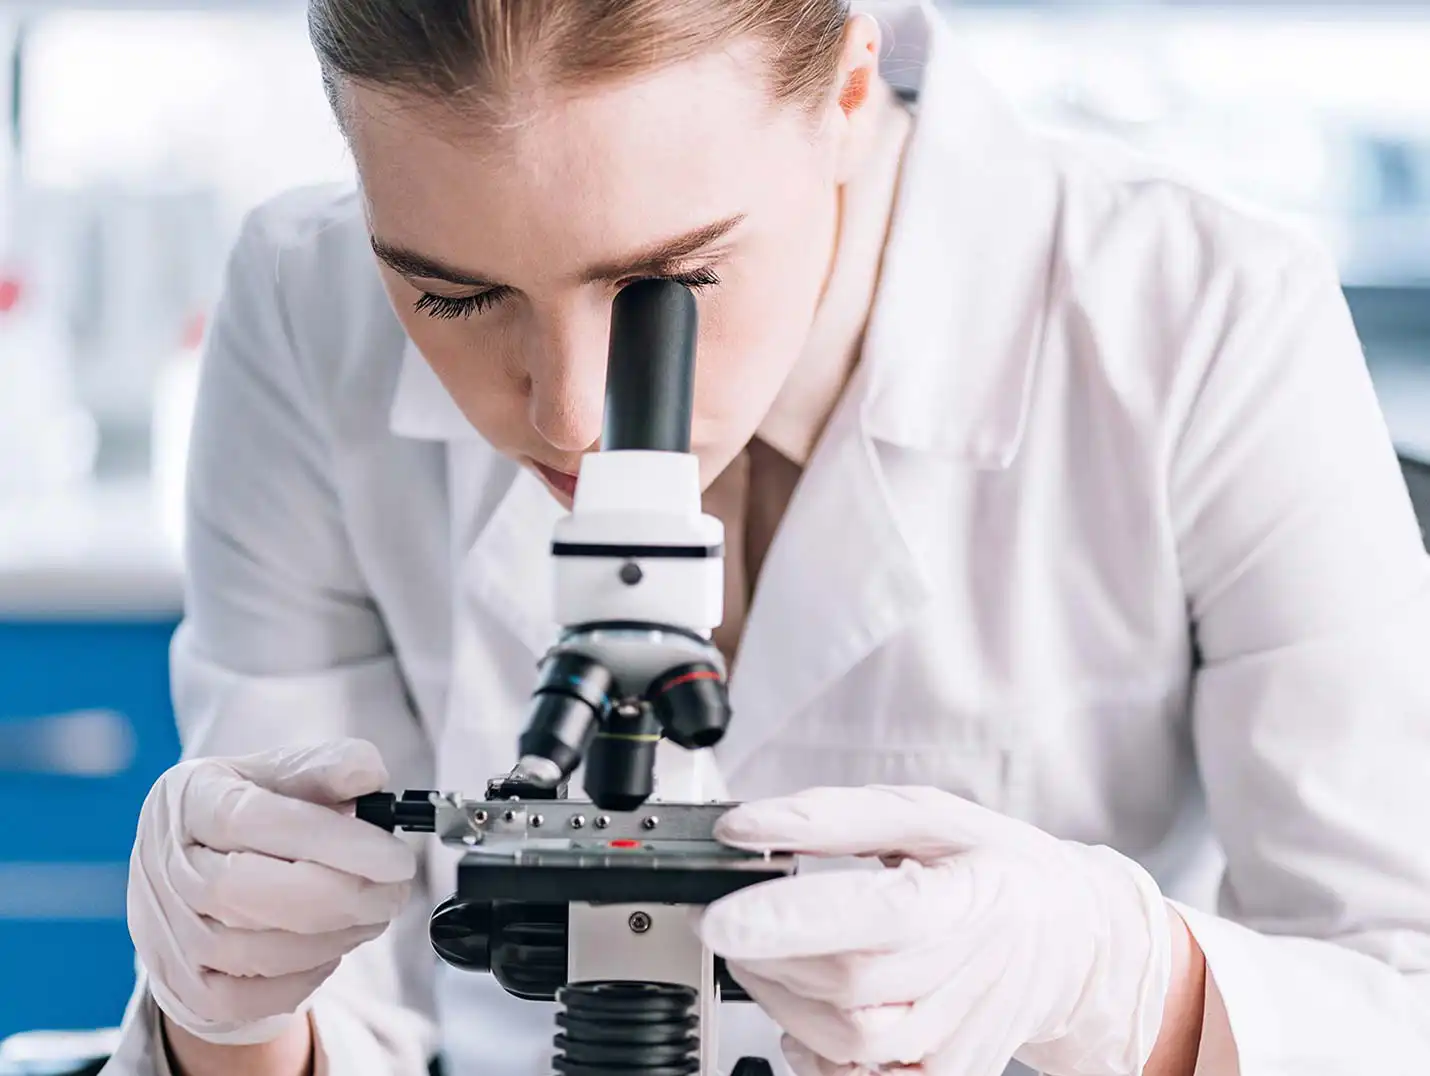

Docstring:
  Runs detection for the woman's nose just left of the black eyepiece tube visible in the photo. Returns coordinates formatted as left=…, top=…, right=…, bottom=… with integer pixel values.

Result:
left=528, top=309, right=609, bottom=452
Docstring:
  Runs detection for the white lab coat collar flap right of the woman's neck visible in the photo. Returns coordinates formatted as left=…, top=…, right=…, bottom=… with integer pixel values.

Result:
left=862, top=4, right=1060, bottom=469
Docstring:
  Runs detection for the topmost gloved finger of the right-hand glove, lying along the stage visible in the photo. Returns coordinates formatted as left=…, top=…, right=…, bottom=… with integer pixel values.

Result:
left=715, top=786, right=1050, bottom=861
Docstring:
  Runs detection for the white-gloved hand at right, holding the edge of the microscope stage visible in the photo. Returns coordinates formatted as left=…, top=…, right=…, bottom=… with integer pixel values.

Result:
left=699, top=787, right=1171, bottom=1076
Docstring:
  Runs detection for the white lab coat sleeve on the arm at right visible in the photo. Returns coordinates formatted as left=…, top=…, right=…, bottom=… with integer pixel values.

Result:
left=1167, top=253, right=1430, bottom=1076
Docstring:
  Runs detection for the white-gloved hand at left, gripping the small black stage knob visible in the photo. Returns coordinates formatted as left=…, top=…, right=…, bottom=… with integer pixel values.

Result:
left=129, top=740, right=416, bottom=1043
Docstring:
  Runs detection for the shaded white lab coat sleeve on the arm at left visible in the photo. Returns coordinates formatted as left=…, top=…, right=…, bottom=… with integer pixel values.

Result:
left=103, top=201, right=435, bottom=1076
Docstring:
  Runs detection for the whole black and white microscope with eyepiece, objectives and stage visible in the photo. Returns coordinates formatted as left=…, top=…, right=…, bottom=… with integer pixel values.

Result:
left=358, top=279, right=795, bottom=1076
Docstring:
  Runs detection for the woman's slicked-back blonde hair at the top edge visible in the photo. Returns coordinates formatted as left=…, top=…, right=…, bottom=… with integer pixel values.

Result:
left=307, top=0, right=849, bottom=121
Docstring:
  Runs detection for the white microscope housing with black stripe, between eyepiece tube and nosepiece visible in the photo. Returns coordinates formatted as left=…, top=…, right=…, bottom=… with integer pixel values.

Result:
left=555, top=452, right=725, bottom=635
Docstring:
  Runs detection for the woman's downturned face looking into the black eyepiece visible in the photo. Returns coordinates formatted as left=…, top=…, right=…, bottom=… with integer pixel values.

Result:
left=343, top=32, right=877, bottom=505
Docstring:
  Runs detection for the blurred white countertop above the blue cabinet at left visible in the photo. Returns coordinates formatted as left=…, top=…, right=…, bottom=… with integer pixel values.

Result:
left=0, top=479, right=183, bottom=620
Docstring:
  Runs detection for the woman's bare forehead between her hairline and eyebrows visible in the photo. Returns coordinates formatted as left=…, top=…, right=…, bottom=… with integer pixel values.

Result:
left=346, top=53, right=811, bottom=280
